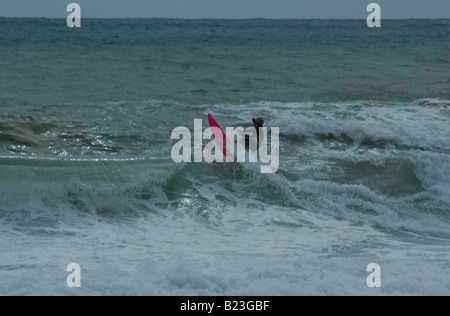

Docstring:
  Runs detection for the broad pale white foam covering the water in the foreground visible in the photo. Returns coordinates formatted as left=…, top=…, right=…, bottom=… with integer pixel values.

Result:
left=0, top=206, right=450, bottom=296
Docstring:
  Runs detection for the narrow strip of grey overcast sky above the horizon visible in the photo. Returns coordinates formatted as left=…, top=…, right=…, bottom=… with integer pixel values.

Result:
left=0, top=0, right=450, bottom=19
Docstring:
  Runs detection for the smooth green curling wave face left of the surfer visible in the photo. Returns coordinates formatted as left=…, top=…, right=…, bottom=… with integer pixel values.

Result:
left=0, top=157, right=180, bottom=226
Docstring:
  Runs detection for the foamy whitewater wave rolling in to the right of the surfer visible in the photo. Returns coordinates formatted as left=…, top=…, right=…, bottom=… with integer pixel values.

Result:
left=283, top=101, right=450, bottom=152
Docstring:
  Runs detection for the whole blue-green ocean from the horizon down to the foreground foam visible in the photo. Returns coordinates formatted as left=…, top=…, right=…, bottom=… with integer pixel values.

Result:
left=0, top=18, right=450, bottom=296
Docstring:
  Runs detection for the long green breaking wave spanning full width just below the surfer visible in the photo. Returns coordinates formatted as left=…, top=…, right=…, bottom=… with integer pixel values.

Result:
left=0, top=148, right=450, bottom=234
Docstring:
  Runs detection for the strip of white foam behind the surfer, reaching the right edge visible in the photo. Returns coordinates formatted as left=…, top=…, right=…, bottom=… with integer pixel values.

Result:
left=224, top=99, right=450, bottom=151
